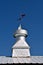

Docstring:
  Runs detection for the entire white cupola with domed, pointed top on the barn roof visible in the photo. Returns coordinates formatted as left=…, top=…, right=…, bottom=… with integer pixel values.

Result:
left=12, top=25, right=30, bottom=57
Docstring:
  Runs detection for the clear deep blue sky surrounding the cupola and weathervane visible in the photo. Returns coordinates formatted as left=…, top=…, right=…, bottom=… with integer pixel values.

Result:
left=0, top=0, right=43, bottom=56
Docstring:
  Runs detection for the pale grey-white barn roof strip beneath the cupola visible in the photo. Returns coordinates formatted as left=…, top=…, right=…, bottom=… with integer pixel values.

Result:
left=0, top=56, right=43, bottom=64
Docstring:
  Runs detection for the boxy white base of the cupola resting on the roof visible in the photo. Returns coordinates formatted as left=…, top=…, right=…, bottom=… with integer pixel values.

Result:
left=12, top=49, right=30, bottom=57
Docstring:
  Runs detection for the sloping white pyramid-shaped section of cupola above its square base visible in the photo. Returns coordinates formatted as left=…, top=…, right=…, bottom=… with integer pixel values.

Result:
left=12, top=40, right=30, bottom=49
